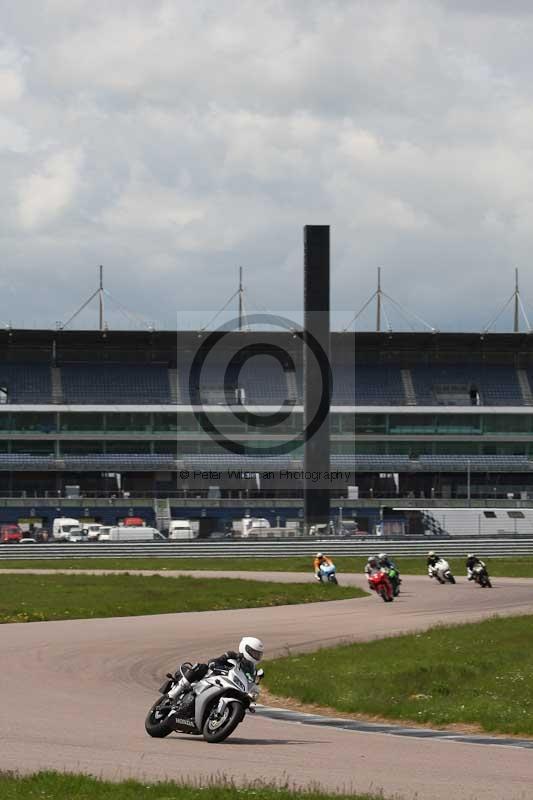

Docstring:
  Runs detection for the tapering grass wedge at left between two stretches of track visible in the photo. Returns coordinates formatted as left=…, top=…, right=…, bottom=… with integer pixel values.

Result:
left=0, top=574, right=365, bottom=623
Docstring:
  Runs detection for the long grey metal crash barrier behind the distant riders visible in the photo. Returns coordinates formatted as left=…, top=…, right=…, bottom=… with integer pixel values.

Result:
left=0, top=536, right=533, bottom=563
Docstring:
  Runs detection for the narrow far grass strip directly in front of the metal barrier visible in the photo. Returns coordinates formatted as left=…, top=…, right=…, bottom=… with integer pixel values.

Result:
left=0, top=544, right=533, bottom=578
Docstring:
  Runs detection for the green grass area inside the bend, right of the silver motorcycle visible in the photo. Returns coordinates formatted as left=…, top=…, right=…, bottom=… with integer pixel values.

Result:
left=264, top=616, right=533, bottom=735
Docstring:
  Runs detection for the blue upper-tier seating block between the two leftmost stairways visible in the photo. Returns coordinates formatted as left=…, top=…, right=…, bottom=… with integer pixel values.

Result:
left=61, top=364, right=171, bottom=405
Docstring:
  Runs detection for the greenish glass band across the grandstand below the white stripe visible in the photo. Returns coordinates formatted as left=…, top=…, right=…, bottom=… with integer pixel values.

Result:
left=0, top=409, right=533, bottom=458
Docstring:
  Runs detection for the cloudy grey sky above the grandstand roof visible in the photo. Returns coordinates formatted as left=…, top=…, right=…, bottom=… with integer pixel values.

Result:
left=0, top=0, right=533, bottom=331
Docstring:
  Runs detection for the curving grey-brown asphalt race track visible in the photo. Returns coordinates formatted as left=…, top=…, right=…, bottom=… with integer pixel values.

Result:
left=0, top=570, right=533, bottom=800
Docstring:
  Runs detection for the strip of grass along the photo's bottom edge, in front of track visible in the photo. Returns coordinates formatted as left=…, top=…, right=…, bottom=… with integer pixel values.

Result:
left=0, top=772, right=382, bottom=800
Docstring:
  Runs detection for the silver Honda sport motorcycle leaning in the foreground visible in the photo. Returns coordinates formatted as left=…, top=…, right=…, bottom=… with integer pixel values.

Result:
left=144, top=659, right=264, bottom=743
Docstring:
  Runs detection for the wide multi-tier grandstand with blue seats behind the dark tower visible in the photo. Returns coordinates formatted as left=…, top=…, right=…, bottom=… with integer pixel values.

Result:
left=0, top=329, right=533, bottom=527
